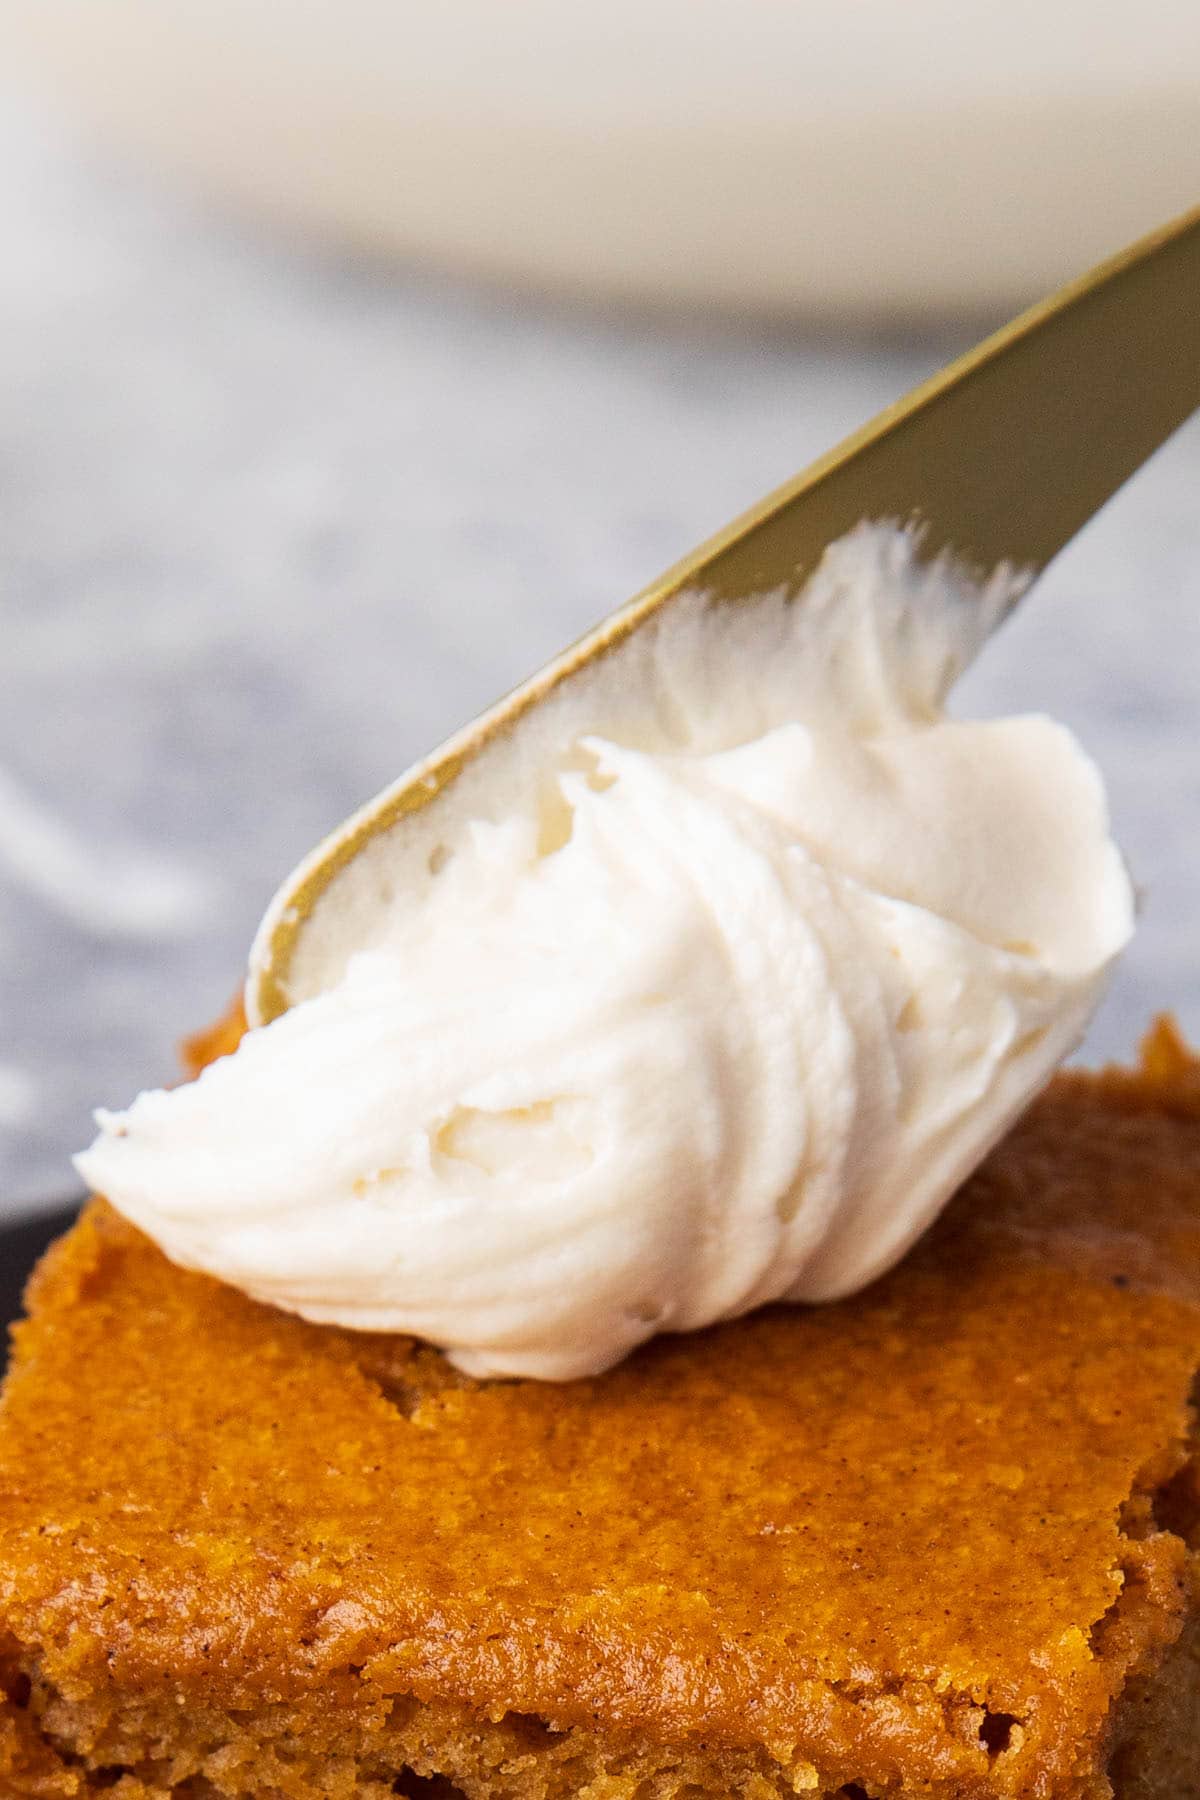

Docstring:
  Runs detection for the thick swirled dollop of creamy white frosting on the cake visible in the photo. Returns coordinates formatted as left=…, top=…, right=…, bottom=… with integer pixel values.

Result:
left=77, top=527, right=1133, bottom=1379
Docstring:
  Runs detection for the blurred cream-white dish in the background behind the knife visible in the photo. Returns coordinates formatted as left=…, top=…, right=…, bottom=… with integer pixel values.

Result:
left=0, top=0, right=1200, bottom=319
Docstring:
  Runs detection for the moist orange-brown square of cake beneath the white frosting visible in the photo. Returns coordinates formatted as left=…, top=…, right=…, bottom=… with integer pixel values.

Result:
left=0, top=1026, right=1200, bottom=1800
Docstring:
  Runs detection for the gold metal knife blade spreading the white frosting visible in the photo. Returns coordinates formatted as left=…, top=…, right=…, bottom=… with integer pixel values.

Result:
left=246, top=207, right=1200, bottom=1024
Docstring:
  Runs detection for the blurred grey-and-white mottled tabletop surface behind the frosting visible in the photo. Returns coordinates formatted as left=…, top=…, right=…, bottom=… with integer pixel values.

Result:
left=0, top=97, right=1200, bottom=1213
